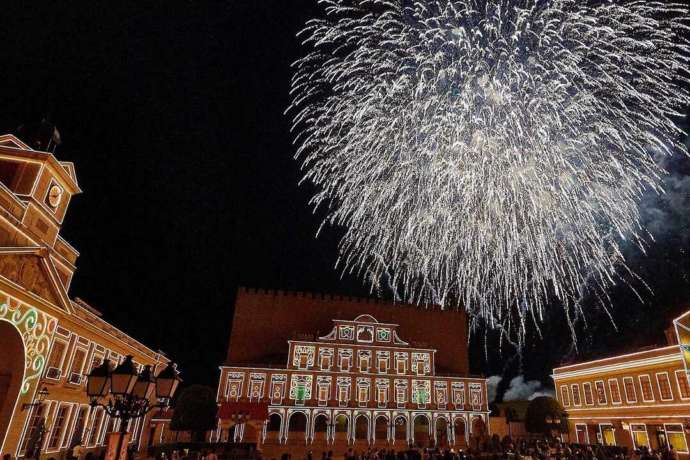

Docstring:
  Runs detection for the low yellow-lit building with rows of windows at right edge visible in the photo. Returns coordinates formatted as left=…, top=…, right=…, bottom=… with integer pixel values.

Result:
left=553, top=312, right=690, bottom=457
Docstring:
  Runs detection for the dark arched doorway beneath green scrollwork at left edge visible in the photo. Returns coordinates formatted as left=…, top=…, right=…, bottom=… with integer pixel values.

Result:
left=0, top=320, right=25, bottom=452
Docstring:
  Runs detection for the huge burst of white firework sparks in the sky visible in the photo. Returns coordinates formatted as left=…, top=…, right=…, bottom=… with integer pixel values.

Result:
left=290, top=0, right=690, bottom=342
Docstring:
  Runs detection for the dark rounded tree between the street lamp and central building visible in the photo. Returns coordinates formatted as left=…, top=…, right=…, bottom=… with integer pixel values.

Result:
left=170, top=385, right=218, bottom=441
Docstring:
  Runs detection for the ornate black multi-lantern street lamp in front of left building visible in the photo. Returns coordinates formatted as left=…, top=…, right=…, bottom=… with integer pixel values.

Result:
left=86, top=355, right=182, bottom=460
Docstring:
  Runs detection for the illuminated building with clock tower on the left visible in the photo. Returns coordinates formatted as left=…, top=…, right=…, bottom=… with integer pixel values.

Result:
left=0, top=135, right=169, bottom=458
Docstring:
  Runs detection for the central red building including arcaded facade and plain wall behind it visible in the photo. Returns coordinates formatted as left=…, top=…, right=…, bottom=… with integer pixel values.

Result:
left=214, top=289, right=488, bottom=450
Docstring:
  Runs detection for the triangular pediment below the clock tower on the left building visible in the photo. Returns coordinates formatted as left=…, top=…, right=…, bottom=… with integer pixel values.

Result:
left=0, top=248, right=70, bottom=311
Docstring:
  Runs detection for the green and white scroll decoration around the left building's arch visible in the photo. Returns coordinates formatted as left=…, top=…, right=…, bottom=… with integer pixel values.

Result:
left=0, top=297, right=57, bottom=395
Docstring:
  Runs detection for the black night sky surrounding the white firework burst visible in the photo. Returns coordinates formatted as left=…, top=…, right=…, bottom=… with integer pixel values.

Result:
left=0, top=0, right=690, bottom=398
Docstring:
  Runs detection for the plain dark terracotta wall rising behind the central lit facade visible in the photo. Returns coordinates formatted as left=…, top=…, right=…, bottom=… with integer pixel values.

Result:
left=226, top=288, right=469, bottom=374
